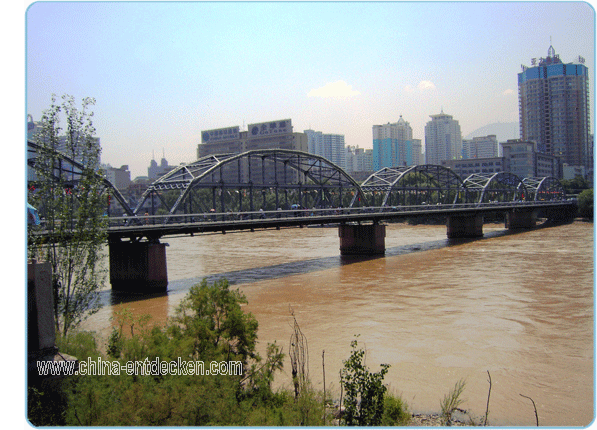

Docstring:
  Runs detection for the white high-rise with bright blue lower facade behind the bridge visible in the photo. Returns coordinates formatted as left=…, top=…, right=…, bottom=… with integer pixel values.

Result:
left=373, top=115, right=421, bottom=170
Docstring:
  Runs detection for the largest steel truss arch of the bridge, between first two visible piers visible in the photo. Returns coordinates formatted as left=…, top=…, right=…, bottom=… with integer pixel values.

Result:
left=133, top=149, right=366, bottom=220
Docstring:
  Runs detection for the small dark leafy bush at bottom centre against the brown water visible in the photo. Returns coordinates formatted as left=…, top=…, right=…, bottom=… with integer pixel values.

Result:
left=340, top=339, right=390, bottom=426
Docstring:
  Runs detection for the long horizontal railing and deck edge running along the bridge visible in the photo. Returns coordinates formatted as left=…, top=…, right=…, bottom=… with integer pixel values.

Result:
left=103, top=199, right=574, bottom=228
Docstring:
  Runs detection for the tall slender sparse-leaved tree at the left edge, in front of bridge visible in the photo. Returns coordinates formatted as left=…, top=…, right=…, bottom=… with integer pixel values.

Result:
left=28, top=95, right=107, bottom=335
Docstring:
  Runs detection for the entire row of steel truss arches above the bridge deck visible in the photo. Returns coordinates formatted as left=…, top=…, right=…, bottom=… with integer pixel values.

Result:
left=27, top=141, right=565, bottom=222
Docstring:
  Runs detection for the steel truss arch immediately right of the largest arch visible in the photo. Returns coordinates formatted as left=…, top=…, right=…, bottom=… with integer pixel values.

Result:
left=354, top=164, right=465, bottom=210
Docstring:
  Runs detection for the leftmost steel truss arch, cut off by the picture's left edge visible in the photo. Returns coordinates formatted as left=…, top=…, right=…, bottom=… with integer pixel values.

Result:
left=27, top=140, right=133, bottom=215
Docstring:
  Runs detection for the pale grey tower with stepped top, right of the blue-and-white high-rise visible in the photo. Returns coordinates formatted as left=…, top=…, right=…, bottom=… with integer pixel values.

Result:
left=425, top=110, right=462, bottom=165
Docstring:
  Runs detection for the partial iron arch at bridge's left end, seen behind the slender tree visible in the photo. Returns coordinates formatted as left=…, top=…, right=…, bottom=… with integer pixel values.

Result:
left=27, top=140, right=133, bottom=215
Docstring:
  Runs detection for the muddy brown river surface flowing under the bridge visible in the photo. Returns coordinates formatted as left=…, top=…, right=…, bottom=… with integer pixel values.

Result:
left=83, top=222, right=595, bottom=426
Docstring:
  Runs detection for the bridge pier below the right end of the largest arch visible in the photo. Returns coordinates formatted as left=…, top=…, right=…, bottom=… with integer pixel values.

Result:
left=338, top=224, right=386, bottom=255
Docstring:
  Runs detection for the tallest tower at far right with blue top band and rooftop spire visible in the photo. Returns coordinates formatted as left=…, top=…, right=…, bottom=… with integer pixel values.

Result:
left=518, top=46, right=592, bottom=175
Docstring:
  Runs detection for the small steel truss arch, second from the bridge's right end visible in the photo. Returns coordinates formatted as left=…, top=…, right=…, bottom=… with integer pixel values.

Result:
left=464, top=172, right=528, bottom=203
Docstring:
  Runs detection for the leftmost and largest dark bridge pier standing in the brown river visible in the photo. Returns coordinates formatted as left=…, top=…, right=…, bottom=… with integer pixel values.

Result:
left=109, top=241, right=168, bottom=293
